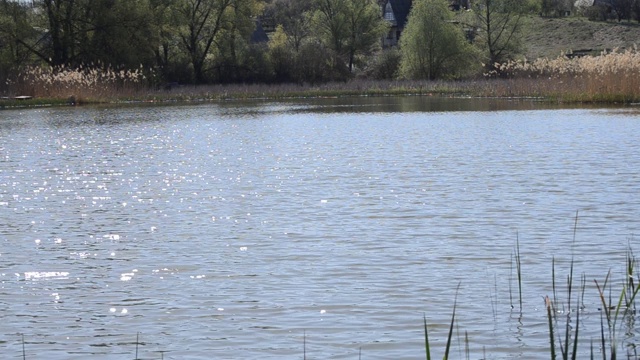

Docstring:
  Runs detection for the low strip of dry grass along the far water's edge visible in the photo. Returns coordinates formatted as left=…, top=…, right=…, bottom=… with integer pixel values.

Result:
left=0, top=78, right=640, bottom=109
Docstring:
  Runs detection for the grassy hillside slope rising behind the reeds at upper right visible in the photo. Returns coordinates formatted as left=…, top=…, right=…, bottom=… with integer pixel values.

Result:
left=524, top=16, right=640, bottom=60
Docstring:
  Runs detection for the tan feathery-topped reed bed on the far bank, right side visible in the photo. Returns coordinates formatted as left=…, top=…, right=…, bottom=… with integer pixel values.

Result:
left=478, top=49, right=640, bottom=103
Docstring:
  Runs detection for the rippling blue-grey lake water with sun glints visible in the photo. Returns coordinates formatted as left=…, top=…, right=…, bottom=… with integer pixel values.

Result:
left=0, top=97, right=640, bottom=360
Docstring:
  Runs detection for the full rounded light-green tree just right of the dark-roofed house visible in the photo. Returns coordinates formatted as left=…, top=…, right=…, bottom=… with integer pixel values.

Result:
left=400, top=0, right=475, bottom=80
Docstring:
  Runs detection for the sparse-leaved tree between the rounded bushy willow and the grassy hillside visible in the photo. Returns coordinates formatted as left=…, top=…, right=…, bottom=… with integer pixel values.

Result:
left=474, top=0, right=528, bottom=70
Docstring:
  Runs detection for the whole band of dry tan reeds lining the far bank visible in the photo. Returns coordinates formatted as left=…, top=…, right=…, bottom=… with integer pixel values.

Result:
left=0, top=48, right=640, bottom=108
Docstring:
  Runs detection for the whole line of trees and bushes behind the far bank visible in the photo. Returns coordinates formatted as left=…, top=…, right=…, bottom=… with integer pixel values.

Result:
left=0, top=0, right=640, bottom=88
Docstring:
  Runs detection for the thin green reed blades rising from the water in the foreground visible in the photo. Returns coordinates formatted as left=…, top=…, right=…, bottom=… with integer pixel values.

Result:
left=424, top=212, right=640, bottom=360
